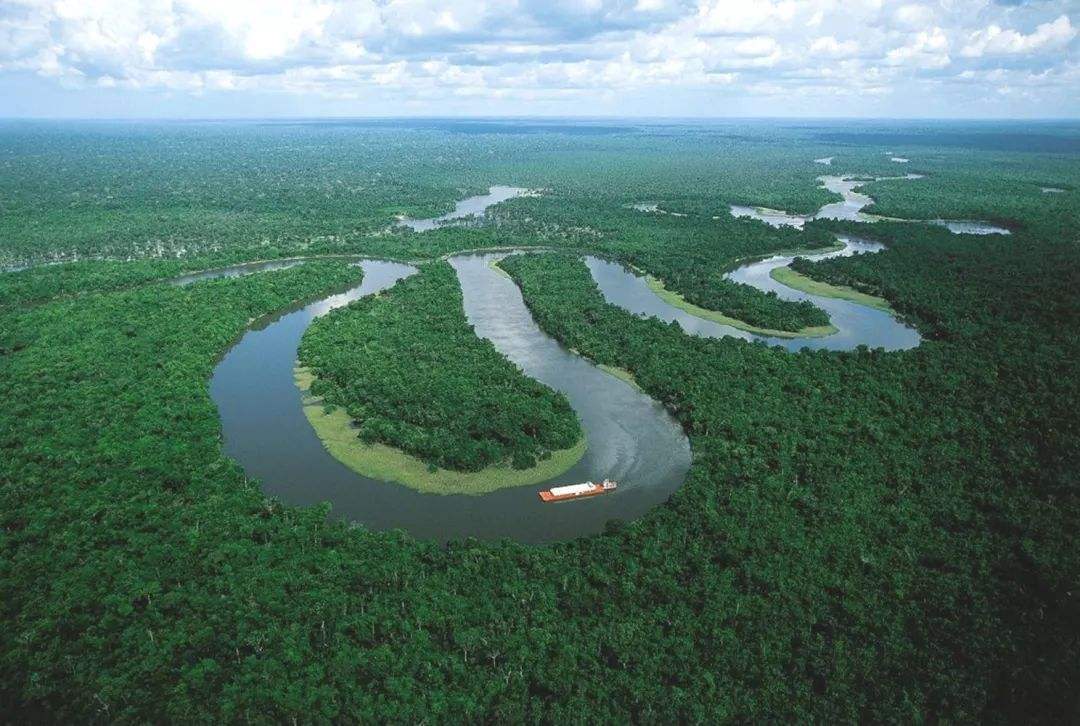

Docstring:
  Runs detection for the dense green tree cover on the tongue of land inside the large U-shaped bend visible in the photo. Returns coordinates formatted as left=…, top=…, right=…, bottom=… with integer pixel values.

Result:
left=299, top=261, right=582, bottom=471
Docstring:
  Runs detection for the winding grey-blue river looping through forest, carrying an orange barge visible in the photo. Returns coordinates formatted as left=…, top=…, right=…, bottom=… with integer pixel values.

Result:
left=206, top=187, right=919, bottom=543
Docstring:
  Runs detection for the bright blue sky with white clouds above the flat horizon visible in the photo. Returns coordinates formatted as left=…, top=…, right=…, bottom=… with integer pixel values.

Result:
left=0, top=0, right=1080, bottom=118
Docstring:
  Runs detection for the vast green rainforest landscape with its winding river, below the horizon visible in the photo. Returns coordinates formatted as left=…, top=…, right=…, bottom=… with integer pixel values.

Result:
left=0, top=119, right=1080, bottom=723
